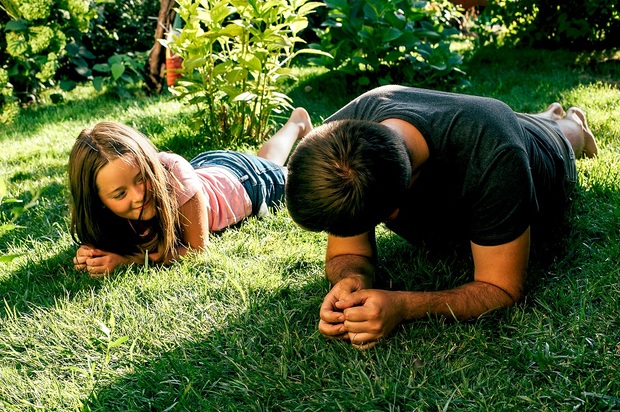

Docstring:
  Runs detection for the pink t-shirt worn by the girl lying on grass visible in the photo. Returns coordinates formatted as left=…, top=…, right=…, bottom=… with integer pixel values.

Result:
left=159, top=152, right=252, bottom=232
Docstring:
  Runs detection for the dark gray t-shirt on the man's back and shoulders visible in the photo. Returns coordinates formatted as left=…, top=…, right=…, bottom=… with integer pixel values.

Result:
left=326, top=86, right=564, bottom=246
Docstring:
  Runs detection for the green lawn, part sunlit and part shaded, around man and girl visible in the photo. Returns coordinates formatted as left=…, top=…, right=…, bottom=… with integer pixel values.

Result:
left=0, top=46, right=620, bottom=411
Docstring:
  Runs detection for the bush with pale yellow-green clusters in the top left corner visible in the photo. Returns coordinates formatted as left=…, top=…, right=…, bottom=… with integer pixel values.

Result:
left=0, top=0, right=159, bottom=123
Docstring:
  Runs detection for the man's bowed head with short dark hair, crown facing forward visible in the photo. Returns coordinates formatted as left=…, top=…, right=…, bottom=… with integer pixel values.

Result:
left=286, top=120, right=411, bottom=236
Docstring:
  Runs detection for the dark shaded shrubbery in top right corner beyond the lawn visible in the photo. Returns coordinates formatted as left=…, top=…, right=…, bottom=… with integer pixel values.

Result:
left=475, top=0, right=620, bottom=51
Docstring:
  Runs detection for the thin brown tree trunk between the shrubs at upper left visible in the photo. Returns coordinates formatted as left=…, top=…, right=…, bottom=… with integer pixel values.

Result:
left=145, top=0, right=176, bottom=94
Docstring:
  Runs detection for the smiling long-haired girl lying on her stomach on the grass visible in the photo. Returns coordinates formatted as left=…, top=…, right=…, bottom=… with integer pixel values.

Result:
left=68, top=108, right=312, bottom=277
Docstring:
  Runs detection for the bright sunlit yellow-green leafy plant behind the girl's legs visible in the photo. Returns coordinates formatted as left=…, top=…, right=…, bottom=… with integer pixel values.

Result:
left=163, top=0, right=330, bottom=145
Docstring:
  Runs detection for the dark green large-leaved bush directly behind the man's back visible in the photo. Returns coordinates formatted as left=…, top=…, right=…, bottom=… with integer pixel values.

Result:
left=311, top=0, right=465, bottom=88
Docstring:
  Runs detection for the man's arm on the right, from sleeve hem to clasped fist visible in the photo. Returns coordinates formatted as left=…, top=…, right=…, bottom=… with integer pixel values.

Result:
left=334, top=228, right=530, bottom=349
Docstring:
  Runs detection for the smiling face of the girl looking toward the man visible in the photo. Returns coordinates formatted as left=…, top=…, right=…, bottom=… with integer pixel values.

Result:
left=95, top=158, right=155, bottom=220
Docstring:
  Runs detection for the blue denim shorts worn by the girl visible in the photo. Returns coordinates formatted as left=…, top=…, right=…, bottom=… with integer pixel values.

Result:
left=189, top=150, right=286, bottom=216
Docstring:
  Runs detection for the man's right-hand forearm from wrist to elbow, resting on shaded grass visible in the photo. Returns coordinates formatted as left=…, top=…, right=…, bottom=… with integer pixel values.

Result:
left=397, top=282, right=516, bottom=320
